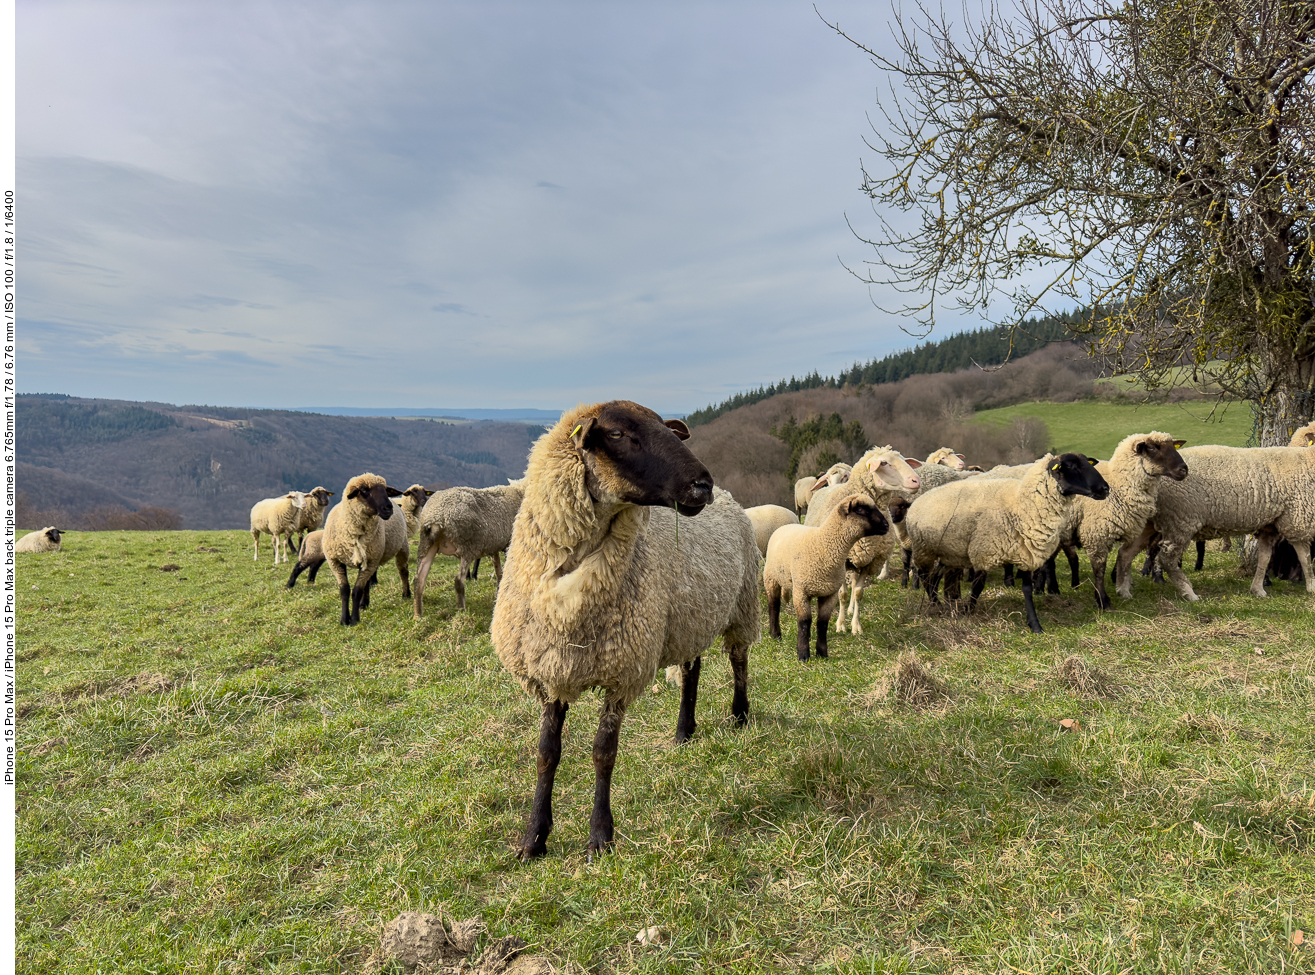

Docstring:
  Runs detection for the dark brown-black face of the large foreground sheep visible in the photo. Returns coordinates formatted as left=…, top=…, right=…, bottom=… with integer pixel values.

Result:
left=571, top=400, right=713, bottom=514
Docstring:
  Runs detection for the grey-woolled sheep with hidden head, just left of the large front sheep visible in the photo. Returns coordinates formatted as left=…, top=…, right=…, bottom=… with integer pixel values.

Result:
left=414, top=478, right=525, bottom=620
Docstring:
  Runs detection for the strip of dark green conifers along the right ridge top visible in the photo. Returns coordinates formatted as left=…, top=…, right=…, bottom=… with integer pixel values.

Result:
left=685, top=313, right=1078, bottom=426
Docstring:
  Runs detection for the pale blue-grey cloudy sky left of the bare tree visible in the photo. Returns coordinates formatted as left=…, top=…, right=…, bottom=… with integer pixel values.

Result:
left=16, top=0, right=982, bottom=414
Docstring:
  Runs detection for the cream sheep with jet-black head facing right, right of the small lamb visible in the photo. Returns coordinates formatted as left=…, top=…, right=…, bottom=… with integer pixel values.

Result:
left=903, top=454, right=1110, bottom=633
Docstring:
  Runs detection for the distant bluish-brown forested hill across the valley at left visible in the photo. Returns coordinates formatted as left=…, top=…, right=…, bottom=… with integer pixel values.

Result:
left=17, top=395, right=543, bottom=529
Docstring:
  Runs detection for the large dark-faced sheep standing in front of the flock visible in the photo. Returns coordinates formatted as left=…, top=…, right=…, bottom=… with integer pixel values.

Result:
left=492, top=400, right=760, bottom=859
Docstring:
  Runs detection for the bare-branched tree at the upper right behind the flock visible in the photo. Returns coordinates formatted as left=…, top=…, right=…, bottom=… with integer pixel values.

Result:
left=831, top=0, right=1315, bottom=445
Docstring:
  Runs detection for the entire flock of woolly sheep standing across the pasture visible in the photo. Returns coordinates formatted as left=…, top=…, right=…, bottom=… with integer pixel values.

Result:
left=20, top=400, right=1315, bottom=858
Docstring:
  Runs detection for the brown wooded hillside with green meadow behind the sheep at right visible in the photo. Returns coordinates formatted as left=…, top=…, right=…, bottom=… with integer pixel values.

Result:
left=689, top=342, right=1230, bottom=507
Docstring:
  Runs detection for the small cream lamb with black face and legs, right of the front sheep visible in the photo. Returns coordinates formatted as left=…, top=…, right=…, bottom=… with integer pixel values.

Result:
left=763, top=493, right=890, bottom=661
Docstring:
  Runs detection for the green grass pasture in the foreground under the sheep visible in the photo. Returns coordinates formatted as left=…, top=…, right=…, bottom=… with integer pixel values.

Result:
left=16, top=528, right=1315, bottom=975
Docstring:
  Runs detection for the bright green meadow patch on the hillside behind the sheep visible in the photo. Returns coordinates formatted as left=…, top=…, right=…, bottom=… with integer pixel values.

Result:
left=973, top=400, right=1253, bottom=461
